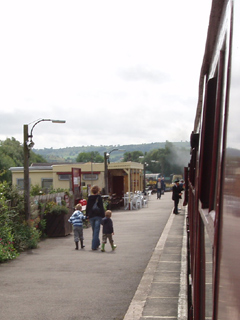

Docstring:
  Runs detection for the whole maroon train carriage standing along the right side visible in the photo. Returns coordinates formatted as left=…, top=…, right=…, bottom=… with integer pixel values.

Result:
left=185, top=0, right=240, bottom=320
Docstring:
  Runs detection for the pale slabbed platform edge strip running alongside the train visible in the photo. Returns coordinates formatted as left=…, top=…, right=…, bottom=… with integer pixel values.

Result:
left=124, top=199, right=187, bottom=320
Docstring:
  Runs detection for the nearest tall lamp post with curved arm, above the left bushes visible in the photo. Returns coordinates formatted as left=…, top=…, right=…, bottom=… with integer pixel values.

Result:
left=23, top=119, right=66, bottom=221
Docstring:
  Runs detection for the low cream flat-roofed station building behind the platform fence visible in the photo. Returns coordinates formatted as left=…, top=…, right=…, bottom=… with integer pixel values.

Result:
left=10, top=161, right=144, bottom=197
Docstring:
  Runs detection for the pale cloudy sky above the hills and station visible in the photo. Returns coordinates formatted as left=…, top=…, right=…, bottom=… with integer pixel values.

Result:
left=0, top=0, right=211, bottom=149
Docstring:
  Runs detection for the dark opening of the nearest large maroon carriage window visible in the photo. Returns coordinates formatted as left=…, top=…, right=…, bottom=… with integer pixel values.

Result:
left=200, top=51, right=225, bottom=211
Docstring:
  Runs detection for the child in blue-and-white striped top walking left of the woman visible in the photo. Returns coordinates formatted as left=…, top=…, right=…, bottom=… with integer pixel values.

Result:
left=68, top=203, right=86, bottom=250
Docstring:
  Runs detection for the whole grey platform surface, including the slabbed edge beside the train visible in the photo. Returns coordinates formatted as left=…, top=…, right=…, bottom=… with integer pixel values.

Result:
left=0, top=193, right=187, bottom=320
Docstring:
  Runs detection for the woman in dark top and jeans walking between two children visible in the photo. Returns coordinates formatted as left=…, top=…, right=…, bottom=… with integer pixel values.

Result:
left=86, top=186, right=105, bottom=250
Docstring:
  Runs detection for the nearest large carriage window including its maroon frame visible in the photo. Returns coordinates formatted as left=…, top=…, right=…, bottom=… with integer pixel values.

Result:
left=199, top=35, right=228, bottom=212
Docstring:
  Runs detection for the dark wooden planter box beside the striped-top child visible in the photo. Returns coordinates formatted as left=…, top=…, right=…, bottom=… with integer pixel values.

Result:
left=46, top=213, right=72, bottom=237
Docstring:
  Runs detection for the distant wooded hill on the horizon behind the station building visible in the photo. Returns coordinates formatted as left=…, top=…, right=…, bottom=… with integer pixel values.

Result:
left=33, top=141, right=190, bottom=162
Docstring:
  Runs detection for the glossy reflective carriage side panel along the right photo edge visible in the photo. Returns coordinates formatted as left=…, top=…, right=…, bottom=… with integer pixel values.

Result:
left=217, top=1, right=240, bottom=320
